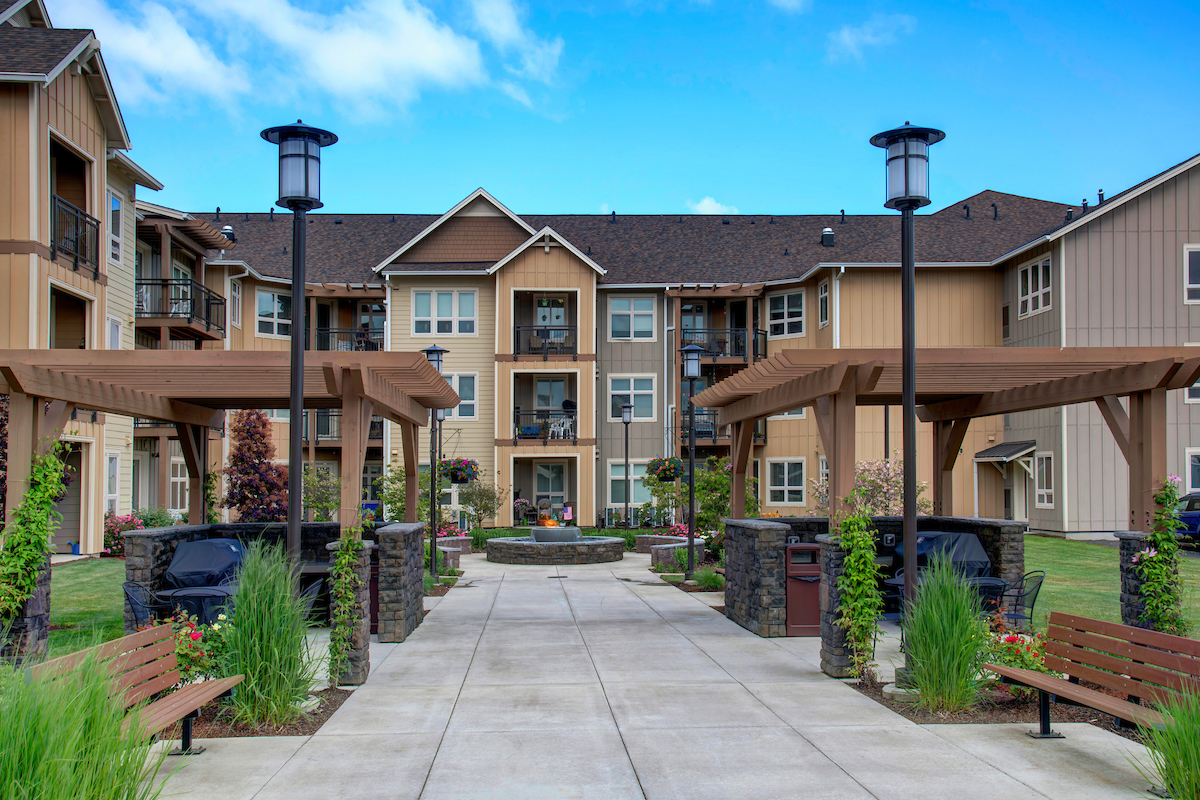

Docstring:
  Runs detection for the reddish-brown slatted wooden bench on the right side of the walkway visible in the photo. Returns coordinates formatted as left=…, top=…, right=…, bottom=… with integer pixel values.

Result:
left=984, top=612, right=1200, bottom=739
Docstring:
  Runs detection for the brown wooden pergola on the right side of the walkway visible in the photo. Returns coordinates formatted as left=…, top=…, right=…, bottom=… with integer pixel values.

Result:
left=696, top=347, right=1200, bottom=530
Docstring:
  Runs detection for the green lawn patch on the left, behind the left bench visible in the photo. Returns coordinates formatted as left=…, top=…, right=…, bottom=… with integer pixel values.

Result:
left=50, top=559, right=125, bottom=658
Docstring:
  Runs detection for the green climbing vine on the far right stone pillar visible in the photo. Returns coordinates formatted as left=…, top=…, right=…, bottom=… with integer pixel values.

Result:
left=1133, top=475, right=1188, bottom=636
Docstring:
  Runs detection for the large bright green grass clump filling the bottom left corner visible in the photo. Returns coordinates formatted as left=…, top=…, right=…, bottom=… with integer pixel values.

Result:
left=0, top=657, right=166, bottom=800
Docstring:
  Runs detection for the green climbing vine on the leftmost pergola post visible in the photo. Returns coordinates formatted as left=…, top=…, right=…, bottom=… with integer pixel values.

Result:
left=0, top=443, right=67, bottom=624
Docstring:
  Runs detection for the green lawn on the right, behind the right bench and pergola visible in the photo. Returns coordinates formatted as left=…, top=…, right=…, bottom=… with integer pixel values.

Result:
left=1025, top=536, right=1200, bottom=634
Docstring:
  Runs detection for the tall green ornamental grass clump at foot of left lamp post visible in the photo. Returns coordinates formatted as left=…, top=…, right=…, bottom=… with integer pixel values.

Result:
left=223, top=541, right=317, bottom=726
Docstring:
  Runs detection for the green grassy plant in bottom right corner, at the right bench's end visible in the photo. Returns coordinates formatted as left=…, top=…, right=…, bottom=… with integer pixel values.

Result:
left=1135, top=692, right=1200, bottom=799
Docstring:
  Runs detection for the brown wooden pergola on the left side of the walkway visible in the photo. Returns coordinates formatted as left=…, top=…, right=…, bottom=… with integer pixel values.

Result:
left=0, top=350, right=458, bottom=531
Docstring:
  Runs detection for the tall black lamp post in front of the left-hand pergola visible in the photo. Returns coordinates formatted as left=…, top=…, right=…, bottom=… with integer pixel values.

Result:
left=262, top=120, right=338, bottom=565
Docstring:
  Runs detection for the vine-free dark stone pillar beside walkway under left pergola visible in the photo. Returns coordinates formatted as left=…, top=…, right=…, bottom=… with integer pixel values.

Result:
left=376, top=522, right=425, bottom=642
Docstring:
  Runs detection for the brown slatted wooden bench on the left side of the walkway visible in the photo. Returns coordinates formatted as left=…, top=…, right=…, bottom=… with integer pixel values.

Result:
left=31, top=625, right=244, bottom=756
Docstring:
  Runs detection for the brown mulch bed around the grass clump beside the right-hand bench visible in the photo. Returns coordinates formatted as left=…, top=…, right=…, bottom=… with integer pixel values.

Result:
left=850, top=681, right=1141, bottom=741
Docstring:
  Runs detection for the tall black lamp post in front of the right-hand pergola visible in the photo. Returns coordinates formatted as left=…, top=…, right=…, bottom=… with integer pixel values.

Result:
left=871, top=122, right=946, bottom=602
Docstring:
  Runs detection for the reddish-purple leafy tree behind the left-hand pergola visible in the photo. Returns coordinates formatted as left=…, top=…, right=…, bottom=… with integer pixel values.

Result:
left=222, top=409, right=288, bottom=522
